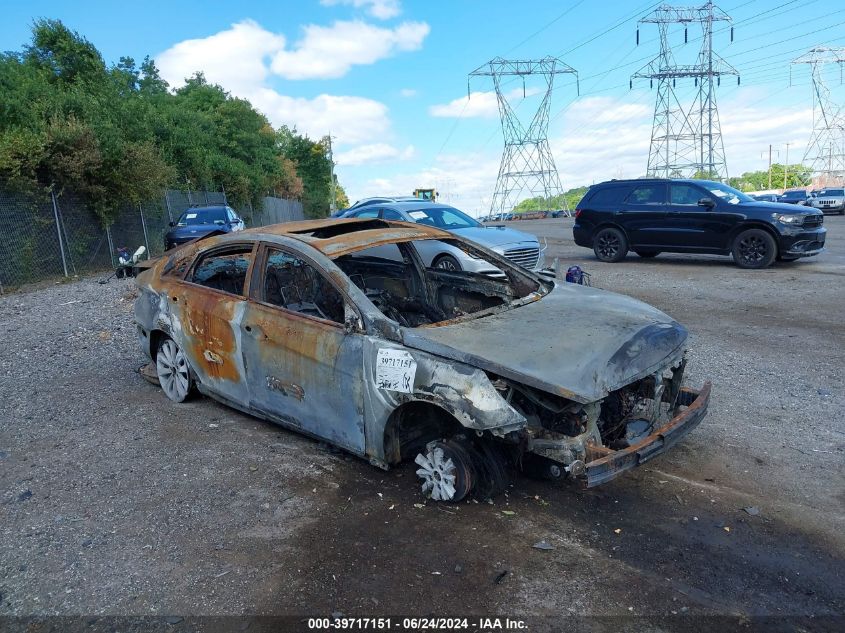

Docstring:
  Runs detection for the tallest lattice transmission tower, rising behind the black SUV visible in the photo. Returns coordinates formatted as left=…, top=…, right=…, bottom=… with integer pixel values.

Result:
left=631, top=2, right=739, bottom=180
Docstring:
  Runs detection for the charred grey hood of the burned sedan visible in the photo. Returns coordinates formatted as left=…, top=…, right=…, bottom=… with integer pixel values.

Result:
left=402, top=283, right=687, bottom=403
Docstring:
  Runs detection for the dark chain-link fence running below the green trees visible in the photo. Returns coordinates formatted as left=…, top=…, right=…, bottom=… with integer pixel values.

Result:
left=0, top=185, right=304, bottom=294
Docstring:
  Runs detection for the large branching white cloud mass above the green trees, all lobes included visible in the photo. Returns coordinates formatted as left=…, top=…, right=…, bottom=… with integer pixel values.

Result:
left=156, top=20, right=429, bottom=145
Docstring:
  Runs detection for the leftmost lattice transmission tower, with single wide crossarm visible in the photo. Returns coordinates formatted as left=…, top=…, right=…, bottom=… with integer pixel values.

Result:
left=467, top=57, right=578, bottom=214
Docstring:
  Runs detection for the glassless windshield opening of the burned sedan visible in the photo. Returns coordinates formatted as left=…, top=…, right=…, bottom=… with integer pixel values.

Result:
left=334, top=240, right=546, bottom=327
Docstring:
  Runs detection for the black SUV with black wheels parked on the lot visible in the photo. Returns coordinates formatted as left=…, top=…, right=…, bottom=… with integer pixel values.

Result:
left=572, top=179, right=827, bottom=268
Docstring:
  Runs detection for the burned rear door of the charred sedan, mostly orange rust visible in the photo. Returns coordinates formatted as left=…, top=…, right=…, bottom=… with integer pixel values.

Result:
left=176, top=243, right=255, bottom=404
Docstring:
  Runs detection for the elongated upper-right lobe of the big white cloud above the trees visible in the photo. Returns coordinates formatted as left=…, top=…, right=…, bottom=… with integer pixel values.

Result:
left=271, top=20, right=431, bottom=79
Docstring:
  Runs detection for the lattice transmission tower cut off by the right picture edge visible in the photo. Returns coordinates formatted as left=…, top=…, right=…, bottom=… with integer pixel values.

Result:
left=792, top=46, right=845, bottom=186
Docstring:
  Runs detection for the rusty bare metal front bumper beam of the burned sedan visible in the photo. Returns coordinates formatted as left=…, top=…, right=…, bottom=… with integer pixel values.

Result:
left=579, top=381, right=711, bottom=488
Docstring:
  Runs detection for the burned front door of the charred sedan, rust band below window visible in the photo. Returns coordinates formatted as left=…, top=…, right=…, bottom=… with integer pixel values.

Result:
left=240, top=245, right=364, bottom=454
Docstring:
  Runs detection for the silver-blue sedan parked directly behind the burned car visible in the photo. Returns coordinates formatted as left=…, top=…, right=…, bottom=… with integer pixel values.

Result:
left=336, top=200, right=545, bottom=275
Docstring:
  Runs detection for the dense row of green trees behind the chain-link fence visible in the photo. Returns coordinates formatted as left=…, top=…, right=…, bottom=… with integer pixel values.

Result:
left=0, top=20, right=342, bottom=222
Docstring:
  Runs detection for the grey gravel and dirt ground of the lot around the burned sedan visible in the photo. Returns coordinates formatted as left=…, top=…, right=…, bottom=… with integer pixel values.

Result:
left=0, top=217, right=845, bottom=631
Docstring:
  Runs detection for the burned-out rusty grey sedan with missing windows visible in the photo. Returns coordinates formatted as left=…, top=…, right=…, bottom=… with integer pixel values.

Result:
left=135, top=219, right=710, bottom=501
